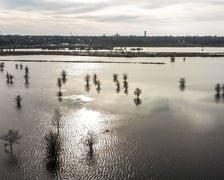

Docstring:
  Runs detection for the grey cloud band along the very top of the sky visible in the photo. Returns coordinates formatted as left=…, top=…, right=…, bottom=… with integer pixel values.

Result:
left=0, top=0, right=224, bottom=14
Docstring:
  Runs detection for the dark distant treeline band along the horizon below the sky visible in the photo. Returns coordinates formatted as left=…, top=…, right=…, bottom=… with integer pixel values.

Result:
left=0, top=35, right=224, bottom=49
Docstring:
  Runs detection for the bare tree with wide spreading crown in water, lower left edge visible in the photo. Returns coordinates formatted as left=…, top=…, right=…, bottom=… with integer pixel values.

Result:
left=0, top=129, right=22, bottom=153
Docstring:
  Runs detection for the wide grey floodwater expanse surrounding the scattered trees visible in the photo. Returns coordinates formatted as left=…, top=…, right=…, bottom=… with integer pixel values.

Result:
left=0, top=56, right=224, bottom=180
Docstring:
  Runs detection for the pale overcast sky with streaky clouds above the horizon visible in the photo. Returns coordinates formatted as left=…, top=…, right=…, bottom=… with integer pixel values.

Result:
left=0, top=0, right=224, bottom=35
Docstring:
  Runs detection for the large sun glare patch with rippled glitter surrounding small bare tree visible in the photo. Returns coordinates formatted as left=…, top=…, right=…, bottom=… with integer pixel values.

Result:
left=57, top=107, right=117, bottom=174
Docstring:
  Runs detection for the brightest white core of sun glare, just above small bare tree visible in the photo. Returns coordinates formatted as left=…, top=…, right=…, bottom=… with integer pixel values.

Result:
left=64, top=107, right=114, bottom=150
